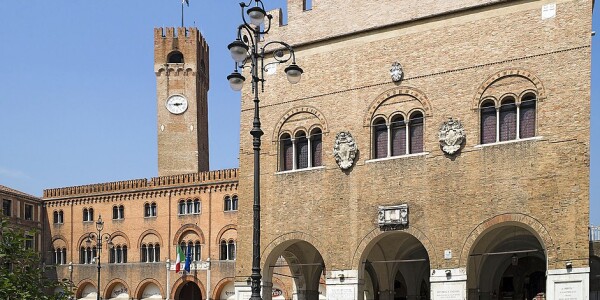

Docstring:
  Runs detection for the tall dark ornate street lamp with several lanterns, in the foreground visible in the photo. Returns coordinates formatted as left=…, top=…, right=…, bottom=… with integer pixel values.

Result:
left=227, top=0, right=303, bottom=300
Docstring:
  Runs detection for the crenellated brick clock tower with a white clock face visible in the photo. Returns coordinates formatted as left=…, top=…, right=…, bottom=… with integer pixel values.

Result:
left=154, top=27, right=209, bottom=176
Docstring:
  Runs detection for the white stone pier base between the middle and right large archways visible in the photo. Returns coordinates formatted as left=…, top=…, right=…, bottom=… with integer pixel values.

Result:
left=429, top=268, right=467, bottom=300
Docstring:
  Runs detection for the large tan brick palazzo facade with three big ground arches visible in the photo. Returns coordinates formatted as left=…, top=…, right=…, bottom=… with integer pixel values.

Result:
left=236, top=0, right=592, bottom=299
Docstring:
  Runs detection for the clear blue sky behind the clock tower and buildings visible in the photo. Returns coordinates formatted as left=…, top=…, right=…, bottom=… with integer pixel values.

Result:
left=0, top=0, right=600, bottom=225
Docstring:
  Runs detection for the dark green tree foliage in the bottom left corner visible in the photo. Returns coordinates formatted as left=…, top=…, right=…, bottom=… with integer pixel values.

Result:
left=0, top=219, right=69, bottom=300
